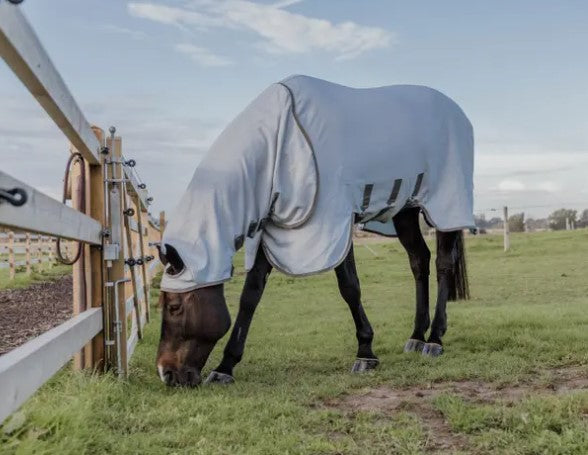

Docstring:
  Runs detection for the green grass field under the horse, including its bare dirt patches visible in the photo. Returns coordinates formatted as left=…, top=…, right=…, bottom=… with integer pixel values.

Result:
left=0, top=230, right=588, bottom=454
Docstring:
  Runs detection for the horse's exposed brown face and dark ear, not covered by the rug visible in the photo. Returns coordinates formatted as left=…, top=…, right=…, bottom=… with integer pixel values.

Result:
left=157, top=246, right=231, bottom=387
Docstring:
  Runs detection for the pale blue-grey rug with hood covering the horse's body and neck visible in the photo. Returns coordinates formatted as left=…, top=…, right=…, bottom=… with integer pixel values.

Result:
left=161, top=76, right=475, bottom=292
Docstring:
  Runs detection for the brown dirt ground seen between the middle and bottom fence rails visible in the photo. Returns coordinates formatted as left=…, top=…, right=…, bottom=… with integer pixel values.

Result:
left=0, top=276, right=72, bottom=355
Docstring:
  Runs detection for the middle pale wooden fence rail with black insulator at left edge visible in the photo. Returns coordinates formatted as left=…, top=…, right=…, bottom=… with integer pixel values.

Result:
left=0, top=171, right=102, bottom=245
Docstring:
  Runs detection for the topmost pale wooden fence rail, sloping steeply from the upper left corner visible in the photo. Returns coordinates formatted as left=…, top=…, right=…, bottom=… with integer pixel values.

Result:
left=0, top=1, right=100, bottom=164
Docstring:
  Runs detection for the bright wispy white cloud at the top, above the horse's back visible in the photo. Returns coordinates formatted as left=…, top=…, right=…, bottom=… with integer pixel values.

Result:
left=128, top=0, right=394, bottom=59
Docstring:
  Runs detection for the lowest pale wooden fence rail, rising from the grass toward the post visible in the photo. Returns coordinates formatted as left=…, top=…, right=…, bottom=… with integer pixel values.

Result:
left=0, top=308, right=102, bottom=422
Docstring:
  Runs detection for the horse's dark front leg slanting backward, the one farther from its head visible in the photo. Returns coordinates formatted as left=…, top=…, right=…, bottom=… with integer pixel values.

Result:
left=335, top=247, right=379, bottom=373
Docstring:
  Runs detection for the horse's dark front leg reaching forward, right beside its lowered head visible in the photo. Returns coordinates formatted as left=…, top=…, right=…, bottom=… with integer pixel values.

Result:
left=206, top=246, right=272, bottom=384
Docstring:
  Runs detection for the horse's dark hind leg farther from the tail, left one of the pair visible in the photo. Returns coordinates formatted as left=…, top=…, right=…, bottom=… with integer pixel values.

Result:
left=394, top=208, right=431, bottom=352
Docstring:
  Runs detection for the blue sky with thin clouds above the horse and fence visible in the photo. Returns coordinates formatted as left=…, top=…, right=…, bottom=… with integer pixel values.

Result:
left=0, top=0, right=588, bottom=217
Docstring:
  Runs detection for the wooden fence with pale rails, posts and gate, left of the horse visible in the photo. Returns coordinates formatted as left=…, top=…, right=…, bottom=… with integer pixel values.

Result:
left=0, top=1, right=164, bottom=422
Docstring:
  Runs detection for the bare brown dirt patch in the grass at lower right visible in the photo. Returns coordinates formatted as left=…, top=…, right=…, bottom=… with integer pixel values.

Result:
left=323, top=366, right=588, bottom=453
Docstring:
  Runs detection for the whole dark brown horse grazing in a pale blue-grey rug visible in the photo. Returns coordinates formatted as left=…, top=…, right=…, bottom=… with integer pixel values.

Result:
left=157, top=76, right=475, bottom=386
